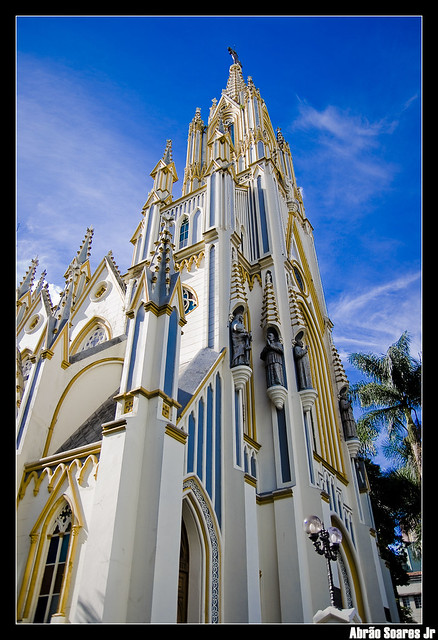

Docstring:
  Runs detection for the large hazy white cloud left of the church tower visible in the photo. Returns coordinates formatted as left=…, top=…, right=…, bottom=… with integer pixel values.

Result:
left=17, top=60, right=161, bottom=285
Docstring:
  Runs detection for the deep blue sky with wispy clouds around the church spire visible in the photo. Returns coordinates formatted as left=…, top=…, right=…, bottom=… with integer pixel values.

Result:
left=16, top=16, right=422, bottom=396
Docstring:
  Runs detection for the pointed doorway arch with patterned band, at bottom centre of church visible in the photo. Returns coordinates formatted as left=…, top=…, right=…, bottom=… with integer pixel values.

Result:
left=183, top=475, right=221, bottom=623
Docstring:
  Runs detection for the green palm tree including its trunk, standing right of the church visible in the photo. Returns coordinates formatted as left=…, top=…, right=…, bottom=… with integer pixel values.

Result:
left=349, top=331, right=422, bottom=557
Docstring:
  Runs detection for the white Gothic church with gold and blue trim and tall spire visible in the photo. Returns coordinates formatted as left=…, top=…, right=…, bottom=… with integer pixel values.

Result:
left=16, top=50, right=398, bottom=624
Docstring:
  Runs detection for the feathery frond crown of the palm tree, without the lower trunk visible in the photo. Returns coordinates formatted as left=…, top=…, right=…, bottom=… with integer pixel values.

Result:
left=349, top=331, right=422, bottom=482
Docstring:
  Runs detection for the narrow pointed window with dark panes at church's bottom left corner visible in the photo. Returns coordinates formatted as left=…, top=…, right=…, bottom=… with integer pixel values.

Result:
left=33, top=504, right=72, bottom=623
